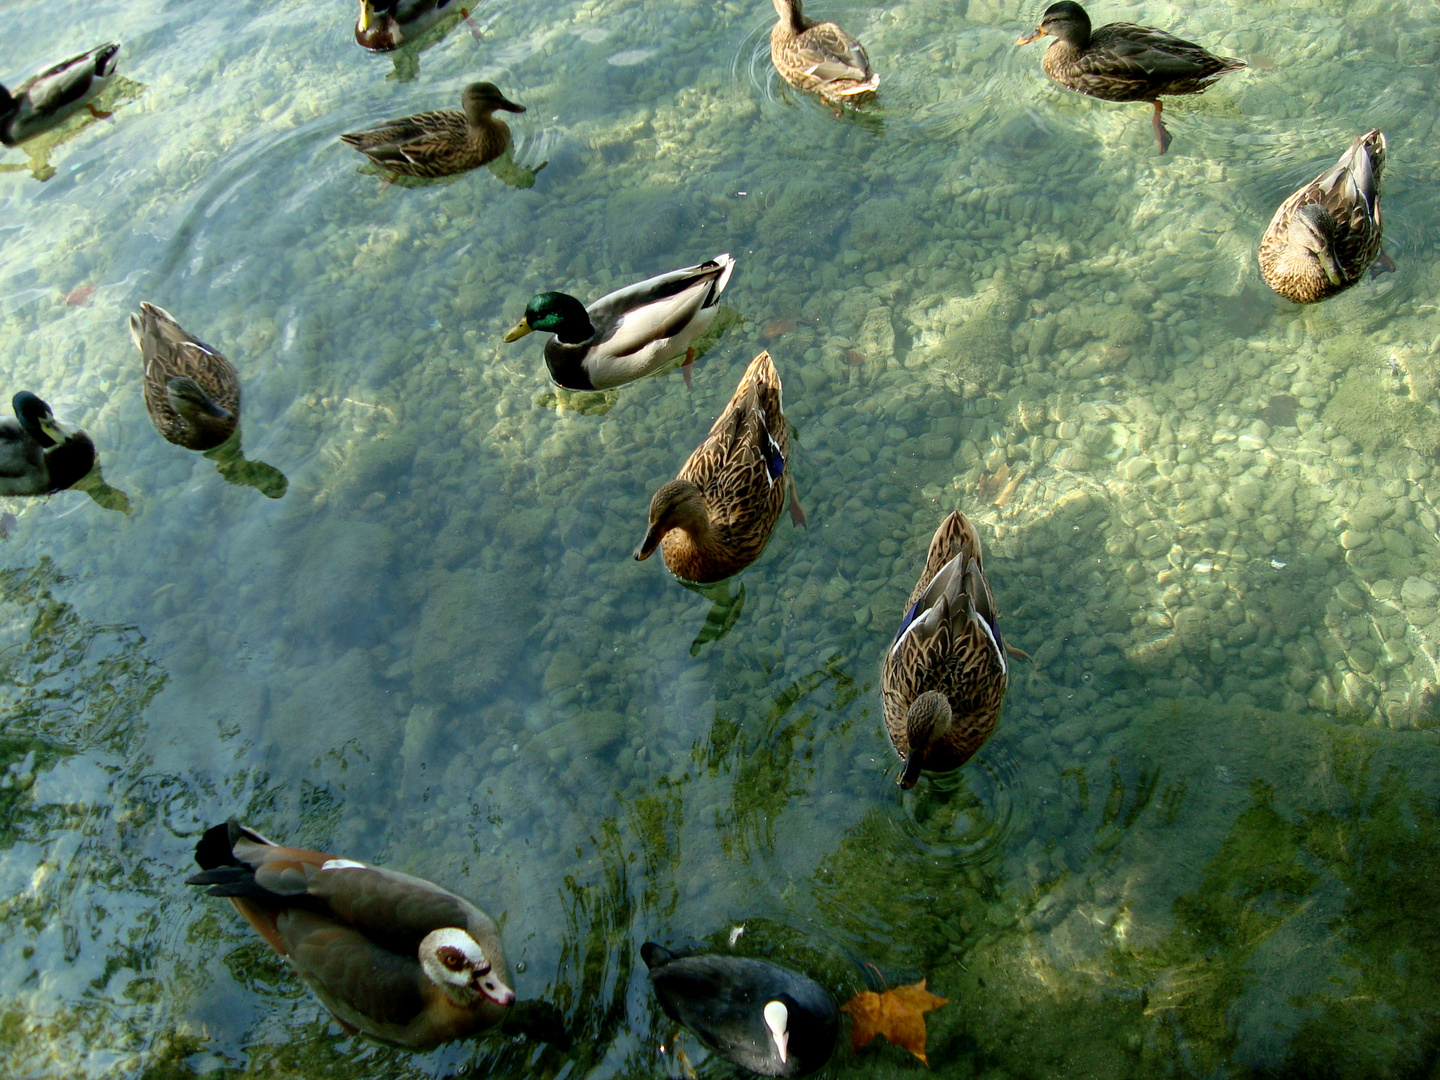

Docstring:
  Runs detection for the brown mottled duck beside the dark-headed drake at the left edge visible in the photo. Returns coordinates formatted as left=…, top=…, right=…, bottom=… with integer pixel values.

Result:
left=130, top=301, right=240, bottom=451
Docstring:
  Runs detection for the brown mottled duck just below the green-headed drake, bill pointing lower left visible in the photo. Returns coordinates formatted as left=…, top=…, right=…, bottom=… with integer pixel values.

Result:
left=635, top=353, right=805, bottom=585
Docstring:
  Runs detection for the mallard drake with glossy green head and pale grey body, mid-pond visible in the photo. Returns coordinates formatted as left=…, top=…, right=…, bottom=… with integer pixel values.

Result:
left=505, top=255, right=731, bottom=390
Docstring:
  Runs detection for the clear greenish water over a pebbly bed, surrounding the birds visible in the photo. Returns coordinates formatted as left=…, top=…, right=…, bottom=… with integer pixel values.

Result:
left=0, top=0, right=1440, bottom=1079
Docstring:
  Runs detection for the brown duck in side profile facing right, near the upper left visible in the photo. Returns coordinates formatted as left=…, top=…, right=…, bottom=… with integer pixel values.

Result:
left=340, top=82, right=526, bottom=177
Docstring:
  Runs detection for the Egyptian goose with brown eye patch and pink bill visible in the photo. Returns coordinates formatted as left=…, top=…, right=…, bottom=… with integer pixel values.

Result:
left=186, top=821, right=516, bottom=1050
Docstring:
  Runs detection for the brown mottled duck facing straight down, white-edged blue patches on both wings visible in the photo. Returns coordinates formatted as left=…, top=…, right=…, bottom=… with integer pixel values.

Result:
left=880, top=510, right=1022, bottom=788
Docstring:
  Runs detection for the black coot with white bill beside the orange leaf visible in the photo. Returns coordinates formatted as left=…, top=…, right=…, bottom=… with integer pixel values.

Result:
left=639, top=942, right=840, bottom=1076
